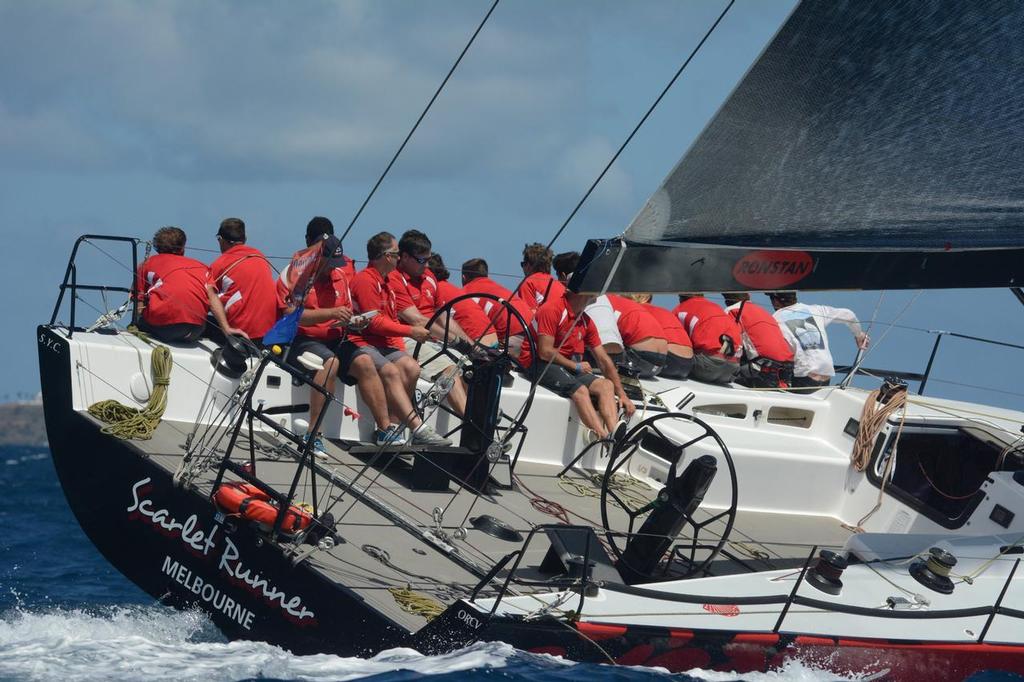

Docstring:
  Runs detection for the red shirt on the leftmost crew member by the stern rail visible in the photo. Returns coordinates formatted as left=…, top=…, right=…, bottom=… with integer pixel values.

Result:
left=135, top=253, right=209, bottom=326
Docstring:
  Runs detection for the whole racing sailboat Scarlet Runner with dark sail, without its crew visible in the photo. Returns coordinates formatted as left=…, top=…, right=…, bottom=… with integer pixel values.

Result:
left=32, top=0, right=1024, bottom=679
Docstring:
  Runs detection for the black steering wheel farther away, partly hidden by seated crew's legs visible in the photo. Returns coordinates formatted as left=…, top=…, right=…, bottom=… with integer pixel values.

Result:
left=413, top=293, right=537, bottom=452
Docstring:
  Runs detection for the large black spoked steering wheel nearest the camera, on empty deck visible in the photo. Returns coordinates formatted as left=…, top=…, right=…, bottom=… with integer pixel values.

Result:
left=601, top=412, right=738, bottom=582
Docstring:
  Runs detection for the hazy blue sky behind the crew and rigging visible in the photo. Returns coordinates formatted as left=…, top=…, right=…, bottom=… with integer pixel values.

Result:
left=0, top=0, right=1024, bottom=409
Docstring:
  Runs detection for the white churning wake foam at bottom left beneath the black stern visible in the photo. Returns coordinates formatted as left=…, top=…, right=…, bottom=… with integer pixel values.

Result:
left=0, top=606, right=515, bottom=682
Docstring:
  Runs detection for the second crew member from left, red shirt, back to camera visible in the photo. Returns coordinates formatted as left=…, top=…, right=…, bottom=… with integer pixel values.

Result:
left=206, top=218, right=278, bottom=343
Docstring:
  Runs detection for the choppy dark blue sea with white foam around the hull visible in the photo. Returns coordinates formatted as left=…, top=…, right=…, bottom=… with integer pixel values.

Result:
left=0, top=447, right=1022, bottom=682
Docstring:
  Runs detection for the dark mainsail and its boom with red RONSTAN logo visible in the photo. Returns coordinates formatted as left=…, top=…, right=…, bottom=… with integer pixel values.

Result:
left=572, top=0, right=1024, bottom=292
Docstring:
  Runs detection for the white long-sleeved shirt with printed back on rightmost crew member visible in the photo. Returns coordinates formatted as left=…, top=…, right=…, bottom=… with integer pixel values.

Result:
left=775, top=303, right=861, bottom=378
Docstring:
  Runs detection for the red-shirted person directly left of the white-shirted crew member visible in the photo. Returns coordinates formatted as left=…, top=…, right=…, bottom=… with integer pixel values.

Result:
left=722, top=293, right=793, bottom=388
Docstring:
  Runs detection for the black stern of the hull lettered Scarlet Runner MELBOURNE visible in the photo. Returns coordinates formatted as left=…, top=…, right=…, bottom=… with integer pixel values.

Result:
left=38, top=327, right=409, bottom=655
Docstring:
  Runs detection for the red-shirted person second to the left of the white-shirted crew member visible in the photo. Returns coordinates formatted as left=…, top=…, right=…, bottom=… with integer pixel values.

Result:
left=673, top=294, right=742, bottom=384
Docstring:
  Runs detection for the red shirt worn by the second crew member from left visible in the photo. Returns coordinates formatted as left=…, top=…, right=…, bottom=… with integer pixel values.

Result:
left=207, top=244, right=278, bottom=339
